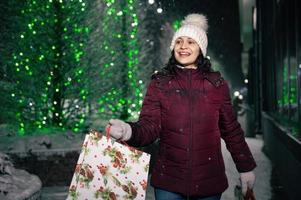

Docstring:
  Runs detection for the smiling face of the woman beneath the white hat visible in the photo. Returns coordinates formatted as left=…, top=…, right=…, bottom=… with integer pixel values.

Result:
left=174, top=36, right=200, bottom=68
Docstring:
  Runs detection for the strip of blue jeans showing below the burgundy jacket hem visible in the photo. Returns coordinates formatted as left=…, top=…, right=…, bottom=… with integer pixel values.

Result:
left=155, top=188, right=222, bottom=200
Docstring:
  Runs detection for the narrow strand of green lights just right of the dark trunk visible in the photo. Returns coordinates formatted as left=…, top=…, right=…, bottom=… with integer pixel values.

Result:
left=63, top=0, right=90, bottom=132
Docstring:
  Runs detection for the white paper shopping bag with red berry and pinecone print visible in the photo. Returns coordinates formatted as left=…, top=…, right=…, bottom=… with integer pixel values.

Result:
left=67, top=130, right=150, bottom=200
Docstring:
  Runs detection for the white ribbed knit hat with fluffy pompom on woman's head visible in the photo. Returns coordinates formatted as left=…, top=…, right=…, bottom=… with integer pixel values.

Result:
left=170, top=14, right=208, bottom=57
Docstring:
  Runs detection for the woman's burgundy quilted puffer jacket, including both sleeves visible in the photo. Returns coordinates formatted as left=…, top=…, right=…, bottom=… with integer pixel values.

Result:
left=128, top=68, right=256, bottom=196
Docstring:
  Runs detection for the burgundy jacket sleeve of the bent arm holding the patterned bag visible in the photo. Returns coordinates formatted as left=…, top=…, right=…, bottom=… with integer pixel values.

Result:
left=127, top=79, right=161, bottom=146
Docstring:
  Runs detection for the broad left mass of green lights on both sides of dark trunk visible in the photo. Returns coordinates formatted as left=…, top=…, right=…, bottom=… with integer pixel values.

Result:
left=11, top=0, right=89, bottom=135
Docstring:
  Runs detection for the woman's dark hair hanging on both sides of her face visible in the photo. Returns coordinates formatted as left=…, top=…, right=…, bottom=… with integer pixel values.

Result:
left=162, top=50, right=213, bottom=75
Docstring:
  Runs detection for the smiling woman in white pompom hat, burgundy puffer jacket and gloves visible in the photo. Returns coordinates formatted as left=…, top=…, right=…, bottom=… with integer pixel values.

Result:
left=108, top=14, right=256, bottom=200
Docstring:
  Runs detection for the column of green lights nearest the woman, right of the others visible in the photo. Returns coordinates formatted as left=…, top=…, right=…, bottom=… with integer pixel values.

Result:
left=98, top=0, right=143, bottom=118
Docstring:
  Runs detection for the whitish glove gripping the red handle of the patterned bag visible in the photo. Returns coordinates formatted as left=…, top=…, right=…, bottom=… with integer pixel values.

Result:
left=106, top=119, right=132, bottom=141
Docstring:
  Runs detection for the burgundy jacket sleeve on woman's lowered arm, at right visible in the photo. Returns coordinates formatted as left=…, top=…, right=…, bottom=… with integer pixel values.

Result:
left=219, top=83, right=256, bottom=172
